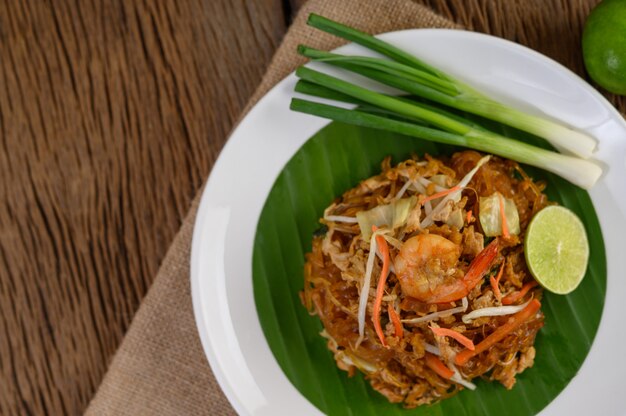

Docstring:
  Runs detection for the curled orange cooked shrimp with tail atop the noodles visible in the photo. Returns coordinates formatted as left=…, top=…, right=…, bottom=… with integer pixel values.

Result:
left=394, top=234, right=498, bottom=303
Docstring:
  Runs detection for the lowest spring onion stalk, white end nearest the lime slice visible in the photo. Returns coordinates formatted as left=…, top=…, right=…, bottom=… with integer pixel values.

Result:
left=291, top=98, right=602, bottom=189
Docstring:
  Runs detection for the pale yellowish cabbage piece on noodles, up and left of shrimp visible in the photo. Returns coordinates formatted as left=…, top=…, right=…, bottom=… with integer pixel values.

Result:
left=356, top=196, right=417, bottom=241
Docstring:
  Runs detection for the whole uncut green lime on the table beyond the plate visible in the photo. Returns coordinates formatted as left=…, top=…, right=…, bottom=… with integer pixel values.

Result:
left=583, top=0, right=626, bottom=94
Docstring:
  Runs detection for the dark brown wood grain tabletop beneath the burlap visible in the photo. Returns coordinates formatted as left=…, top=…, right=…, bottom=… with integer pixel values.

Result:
left=0, top=0, right=624, bottom=415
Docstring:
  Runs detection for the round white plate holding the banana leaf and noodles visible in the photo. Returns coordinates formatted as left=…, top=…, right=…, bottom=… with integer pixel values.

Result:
left=191, top=29, right=626, bottom=416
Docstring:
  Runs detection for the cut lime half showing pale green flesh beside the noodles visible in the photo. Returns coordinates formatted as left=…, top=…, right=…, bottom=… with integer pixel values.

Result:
left=524, top=205, right=589, bottom=295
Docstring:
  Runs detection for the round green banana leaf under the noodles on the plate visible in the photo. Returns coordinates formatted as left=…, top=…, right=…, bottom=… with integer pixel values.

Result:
left=252, top=123, right=606, bottom=416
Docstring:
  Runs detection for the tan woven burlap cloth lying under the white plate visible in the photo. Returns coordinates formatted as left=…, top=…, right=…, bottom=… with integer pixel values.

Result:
left=87, top=0, right=455, bottom=415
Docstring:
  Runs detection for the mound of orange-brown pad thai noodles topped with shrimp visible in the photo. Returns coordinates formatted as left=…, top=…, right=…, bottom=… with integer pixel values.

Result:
left=301, top=151, right=549, bottom=408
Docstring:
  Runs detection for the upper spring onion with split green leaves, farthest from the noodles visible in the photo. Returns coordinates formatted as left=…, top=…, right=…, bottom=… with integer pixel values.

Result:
left=299, top=14, right=596, bottom=158
